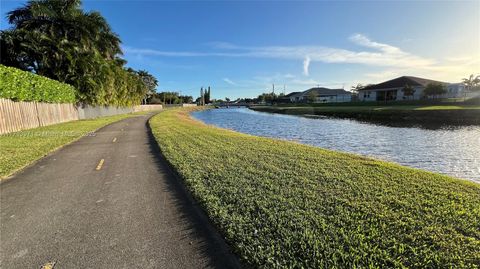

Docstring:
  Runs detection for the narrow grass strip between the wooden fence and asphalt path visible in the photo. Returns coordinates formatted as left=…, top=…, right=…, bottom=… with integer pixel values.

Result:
left=0, top=112, right=144, bottom=179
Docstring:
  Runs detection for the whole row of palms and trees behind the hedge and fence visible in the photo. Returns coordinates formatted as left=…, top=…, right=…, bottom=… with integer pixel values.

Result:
left=0, top=0, right=158, bottom=106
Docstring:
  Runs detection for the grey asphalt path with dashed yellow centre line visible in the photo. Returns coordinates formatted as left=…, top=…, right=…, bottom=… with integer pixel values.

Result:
left=0, top=115, right=239, bottom=268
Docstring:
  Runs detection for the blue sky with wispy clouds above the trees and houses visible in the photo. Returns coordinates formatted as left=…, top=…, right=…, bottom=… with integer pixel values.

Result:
left=0, top=0, right=480, bottom=99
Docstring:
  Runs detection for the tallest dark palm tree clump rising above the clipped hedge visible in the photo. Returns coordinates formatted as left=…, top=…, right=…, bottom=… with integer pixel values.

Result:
left=2, top=0, right=121, bottom=100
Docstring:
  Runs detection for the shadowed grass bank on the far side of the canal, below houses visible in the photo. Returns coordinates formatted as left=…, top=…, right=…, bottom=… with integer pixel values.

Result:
left=250, top=105, right=480, bottom=125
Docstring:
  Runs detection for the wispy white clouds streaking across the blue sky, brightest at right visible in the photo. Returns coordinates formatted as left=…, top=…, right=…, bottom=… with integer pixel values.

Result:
left=123, top=34, right=480, bottom=90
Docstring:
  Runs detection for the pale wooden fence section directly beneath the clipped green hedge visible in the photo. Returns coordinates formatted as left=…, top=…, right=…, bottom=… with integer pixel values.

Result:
left=0, top=98, right=78, bottom=134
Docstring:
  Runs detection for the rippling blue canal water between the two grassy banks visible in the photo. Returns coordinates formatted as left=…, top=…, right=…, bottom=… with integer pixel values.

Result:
left=192, top=108, right=480, bottom=183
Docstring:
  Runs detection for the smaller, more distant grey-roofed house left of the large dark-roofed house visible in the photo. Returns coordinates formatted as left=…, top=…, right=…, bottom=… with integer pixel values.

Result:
left=290, top=87, right=352, bottom=103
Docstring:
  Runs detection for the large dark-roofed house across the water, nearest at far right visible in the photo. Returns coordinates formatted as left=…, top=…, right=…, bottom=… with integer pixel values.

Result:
left=358, top=76, right=465, bottom=101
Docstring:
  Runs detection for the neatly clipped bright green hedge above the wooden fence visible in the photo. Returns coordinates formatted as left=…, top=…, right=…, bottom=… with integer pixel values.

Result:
left=0, top=65, right=76, bottom=103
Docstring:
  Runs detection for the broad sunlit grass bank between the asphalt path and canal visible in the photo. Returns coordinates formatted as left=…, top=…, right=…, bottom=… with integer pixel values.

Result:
left=150, top=109, right=480, bottom=268
